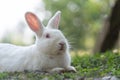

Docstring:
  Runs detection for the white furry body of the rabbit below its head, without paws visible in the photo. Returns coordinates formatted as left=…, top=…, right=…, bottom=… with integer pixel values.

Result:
left=0, top=44, right=70, bottom=72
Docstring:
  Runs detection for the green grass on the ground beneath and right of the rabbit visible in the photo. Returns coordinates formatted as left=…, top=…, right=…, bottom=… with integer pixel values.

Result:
left=0, top=52, right=120, bottom=80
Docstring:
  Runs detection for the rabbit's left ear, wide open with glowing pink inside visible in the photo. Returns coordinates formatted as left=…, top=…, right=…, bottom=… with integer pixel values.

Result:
left=25, top=12, right=43, bottom=35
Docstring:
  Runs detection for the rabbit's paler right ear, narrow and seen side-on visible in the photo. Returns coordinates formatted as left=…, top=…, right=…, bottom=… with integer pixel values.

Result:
left=47, top=11, right=61, bottom=29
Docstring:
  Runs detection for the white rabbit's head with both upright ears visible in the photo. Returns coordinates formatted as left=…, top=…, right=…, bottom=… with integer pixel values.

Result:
left=25, top=11, right=69, bottom=55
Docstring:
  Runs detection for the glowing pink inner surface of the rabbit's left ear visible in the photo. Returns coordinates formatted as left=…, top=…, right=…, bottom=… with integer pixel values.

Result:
left=25, top=12, right=40, bottom=32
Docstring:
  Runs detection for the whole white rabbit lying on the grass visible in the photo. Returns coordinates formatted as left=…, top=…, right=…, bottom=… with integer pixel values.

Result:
left=0, top=11, right=76, bottom=72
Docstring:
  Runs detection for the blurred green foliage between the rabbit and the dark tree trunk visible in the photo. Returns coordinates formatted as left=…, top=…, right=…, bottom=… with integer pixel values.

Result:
left=44, top=0, right=111, bottom=49
